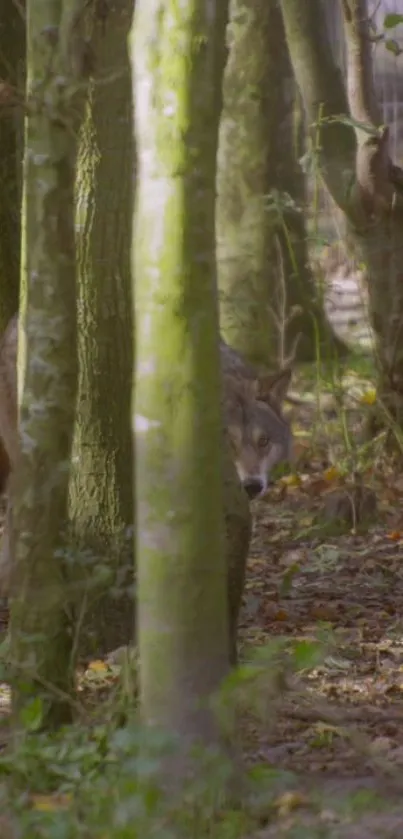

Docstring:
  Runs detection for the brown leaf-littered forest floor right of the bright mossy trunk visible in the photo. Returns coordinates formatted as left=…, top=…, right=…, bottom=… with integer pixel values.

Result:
left=0, top=356, right=403, bottom=839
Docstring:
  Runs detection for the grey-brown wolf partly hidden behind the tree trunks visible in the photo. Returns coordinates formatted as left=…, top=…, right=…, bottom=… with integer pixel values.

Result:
left=0, top=314, right=292, bottom=597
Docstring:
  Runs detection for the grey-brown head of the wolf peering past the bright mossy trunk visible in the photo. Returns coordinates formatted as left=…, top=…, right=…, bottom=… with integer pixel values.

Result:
left=224, top=369, right=293, bottom=499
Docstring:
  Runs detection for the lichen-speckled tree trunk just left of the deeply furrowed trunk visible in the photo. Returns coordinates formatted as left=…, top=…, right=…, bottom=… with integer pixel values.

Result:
left=11, top=0, right=88, bottom=726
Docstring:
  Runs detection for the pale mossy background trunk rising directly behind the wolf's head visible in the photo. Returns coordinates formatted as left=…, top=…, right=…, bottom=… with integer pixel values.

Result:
left=216, top=0, right=277, bottom=364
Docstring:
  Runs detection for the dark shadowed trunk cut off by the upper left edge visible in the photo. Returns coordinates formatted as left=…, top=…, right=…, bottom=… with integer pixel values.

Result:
left=0, top=0, right=25, bottom=334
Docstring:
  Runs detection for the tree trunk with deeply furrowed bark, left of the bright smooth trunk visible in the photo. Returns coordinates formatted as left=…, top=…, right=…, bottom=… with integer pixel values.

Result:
left=70, top=0, right=134, bottom=655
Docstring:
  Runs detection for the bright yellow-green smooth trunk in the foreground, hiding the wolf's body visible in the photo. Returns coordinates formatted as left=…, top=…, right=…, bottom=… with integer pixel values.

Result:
left=131, top=0, right=235, bottom=747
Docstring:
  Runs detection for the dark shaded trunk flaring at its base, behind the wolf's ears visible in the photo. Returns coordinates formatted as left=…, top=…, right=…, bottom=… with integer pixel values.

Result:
left=267, top=3, right=346, bottom=361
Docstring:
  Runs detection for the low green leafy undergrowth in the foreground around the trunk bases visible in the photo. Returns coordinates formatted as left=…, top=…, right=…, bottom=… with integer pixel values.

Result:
left=0, top=633, right=329, bottom=839
